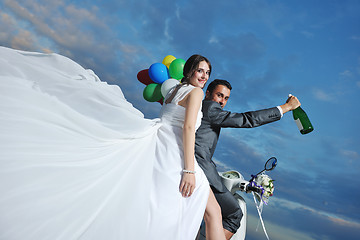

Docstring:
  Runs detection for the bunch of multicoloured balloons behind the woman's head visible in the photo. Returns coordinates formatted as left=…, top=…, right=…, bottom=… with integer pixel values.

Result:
left=137, top=55, right=185, bottom=104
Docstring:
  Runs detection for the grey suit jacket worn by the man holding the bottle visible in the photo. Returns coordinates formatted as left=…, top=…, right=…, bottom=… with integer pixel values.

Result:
left=195, top=100, right=281, bottom=193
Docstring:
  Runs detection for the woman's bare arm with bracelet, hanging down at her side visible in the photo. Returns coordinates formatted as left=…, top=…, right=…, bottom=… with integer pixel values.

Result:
left=180, top=88, right=204, bottom=197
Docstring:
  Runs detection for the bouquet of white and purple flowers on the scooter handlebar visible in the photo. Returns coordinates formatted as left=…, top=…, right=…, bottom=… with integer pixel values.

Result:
left=250, top=174, right=275, bottom=204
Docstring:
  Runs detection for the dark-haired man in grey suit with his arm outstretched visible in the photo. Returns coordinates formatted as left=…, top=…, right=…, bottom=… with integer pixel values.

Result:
left=195, top=79, right=300, bottom=239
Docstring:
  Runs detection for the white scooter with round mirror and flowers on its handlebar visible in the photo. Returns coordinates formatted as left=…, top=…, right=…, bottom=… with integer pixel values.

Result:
left=197, top=157, right=277, bottom=240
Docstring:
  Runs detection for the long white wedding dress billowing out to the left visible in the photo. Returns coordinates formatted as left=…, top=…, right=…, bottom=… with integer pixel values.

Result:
left=0, top=47, right=209, bottom=240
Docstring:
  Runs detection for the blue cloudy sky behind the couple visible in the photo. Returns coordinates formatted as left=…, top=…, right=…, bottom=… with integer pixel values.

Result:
left=0, top=0, right=360, bottom=240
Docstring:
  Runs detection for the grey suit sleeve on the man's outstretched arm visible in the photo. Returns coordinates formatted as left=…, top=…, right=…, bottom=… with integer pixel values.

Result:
left=203, top=102, right=281, bottom=128
